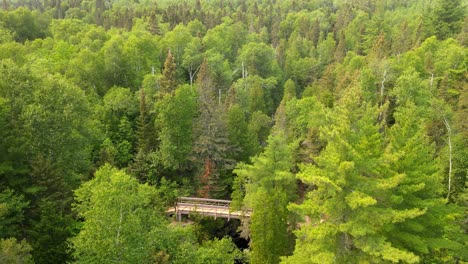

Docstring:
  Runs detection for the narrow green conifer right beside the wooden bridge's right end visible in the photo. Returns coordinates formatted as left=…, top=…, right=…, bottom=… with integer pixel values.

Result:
left=233, top=132, right=296, bottom=264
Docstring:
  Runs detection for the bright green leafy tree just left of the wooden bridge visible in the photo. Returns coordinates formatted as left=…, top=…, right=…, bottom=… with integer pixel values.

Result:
left=71, top=165, right=164, bottom=263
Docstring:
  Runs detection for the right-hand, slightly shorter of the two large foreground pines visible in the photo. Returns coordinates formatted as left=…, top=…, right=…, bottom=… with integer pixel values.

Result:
left=385, top=102, right=461, bottom=262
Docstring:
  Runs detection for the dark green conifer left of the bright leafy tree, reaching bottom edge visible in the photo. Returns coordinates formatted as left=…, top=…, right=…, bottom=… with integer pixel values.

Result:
left=27, top=156, right=75, bottom=263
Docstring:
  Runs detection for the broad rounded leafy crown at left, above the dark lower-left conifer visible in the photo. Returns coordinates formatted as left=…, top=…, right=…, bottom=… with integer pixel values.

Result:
left=22, top=77, right=94, bottom=175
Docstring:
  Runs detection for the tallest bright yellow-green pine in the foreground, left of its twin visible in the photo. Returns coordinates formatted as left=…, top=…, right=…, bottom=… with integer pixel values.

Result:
left=286, top=86, right=396, bottom=263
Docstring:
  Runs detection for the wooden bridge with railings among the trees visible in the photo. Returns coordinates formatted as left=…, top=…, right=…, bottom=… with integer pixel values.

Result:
left=167, top=197, right=251, bottom=221
